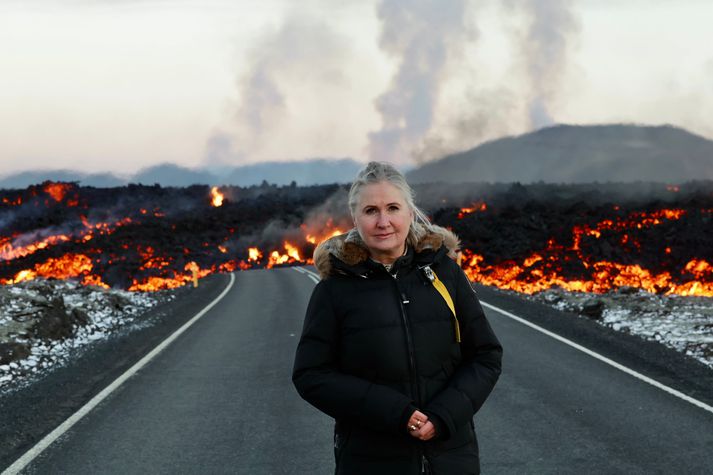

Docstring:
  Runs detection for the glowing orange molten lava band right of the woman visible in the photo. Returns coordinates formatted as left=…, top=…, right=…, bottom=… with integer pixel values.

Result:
left=462, top=208, right=713, bottom=297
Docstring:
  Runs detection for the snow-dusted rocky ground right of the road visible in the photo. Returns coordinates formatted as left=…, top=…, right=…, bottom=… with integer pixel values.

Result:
left=518, top=287, right=713, bottom=369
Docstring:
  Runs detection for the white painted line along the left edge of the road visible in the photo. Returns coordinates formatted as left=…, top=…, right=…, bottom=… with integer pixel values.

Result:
left=2, top=273, right=235, bottom=475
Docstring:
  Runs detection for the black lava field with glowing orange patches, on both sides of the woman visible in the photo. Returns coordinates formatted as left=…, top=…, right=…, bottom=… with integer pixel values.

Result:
left=0, top=182, right=713, bottom=296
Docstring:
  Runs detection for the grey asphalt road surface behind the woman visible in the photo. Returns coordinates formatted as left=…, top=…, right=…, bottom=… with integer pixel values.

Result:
left=4, top=269, right=713, bottom=474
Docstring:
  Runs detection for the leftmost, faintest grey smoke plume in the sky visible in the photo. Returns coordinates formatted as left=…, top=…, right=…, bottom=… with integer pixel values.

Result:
left=206, top=12, right=345, bottom=169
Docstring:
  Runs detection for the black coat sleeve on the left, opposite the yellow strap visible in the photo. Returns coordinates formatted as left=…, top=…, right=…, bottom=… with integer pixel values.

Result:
left=292, top=281, right=413, bottom=432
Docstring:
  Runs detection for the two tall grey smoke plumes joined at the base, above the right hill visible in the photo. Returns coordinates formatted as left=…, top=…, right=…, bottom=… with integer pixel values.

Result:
left=369, top=0, right=579, bottom=163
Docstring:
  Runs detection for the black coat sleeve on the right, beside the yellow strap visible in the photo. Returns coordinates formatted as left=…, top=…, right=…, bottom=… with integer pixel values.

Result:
left=425, top=266, right=503, bottom=434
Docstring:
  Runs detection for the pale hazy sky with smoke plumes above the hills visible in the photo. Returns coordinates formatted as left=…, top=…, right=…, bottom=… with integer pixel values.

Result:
left=0, top=0, right=713, bottom=175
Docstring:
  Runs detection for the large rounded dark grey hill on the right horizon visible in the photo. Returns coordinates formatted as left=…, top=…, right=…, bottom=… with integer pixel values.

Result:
left=408, top=124, right=713, bottom=183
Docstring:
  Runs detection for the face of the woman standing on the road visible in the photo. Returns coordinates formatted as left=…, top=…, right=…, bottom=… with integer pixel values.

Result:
left=354, top=181, right=413, bottom=264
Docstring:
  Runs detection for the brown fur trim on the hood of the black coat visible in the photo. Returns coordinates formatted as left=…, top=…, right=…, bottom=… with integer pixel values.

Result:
left=313, top=224, right=460, bottom=279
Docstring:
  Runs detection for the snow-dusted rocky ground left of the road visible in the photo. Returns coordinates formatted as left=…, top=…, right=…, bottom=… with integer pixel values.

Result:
left=0, top=279, right=173, bottom=391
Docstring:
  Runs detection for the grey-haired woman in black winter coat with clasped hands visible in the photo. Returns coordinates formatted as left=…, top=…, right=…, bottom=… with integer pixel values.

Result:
left=292, top=162, right=502, bottom=475
